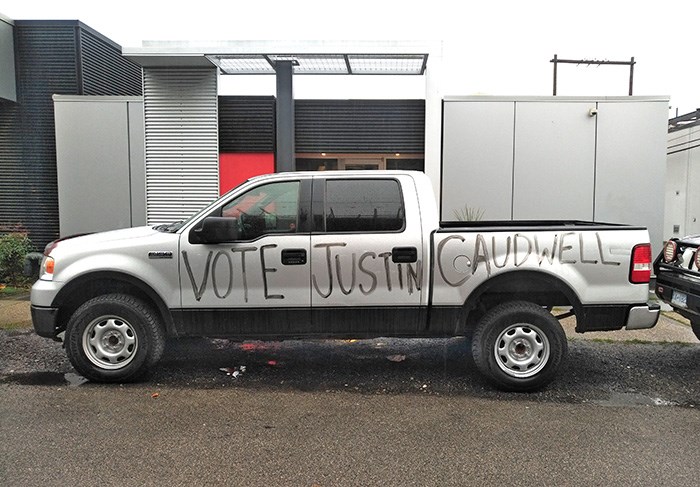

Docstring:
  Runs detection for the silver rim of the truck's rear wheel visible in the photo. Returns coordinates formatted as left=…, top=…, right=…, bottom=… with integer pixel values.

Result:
left=493, top=323, right=550, bottom=379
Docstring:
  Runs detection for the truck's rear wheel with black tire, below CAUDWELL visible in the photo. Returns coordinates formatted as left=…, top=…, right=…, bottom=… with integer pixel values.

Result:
left=472, top=301, right=568, bottom=392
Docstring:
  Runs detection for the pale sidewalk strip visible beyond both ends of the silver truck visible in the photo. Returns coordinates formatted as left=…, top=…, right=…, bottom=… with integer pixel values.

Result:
left=0, top=293, right=698, bottom=343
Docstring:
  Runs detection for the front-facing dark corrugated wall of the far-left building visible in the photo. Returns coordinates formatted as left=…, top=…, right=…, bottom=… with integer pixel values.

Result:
left=8, top=21, right=79, bottom=247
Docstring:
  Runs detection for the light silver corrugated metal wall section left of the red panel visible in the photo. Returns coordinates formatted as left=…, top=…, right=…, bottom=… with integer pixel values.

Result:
left=144, top=68, right=219, bottom=224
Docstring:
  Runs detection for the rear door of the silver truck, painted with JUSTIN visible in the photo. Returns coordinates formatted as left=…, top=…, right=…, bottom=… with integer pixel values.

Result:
left=311, top=173, right=426, bottom=337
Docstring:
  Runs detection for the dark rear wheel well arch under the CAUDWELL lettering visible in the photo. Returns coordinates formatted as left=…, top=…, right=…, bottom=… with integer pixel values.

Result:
left=464, top=271, right=581, bottom=332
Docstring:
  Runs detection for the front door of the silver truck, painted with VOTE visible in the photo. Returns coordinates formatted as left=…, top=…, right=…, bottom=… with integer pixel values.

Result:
left=179, top=178, right=311, bottom=337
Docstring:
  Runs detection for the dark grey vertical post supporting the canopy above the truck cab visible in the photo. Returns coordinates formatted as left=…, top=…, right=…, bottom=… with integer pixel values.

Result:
left=275, top=61, right=296, bottom=172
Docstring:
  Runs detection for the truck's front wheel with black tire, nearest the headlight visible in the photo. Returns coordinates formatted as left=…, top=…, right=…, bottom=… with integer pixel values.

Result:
left=65, top=294, right=165, bottom=382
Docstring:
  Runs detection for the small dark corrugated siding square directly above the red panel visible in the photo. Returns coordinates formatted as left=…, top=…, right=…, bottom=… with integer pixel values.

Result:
left=219, top=96, right=275, bottom=152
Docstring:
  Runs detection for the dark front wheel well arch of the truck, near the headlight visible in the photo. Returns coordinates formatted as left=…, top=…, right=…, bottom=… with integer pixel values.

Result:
left=53, top=272, right=173, bottom=334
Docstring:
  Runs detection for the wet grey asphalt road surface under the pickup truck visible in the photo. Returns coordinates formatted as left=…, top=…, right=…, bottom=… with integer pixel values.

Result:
left=0, top=331, right=700, bottom=486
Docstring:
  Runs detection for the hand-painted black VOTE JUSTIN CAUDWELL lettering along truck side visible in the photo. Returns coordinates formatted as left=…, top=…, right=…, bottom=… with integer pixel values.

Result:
left=182, top=232, right=621, bottom=303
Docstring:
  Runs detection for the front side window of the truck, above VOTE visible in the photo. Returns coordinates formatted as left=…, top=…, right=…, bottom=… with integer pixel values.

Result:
left=221, top=181, right=299, bottom=240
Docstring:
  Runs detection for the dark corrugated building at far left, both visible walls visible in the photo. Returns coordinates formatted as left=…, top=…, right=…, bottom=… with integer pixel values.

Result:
left=0, top=19, right=141, bottom=247
